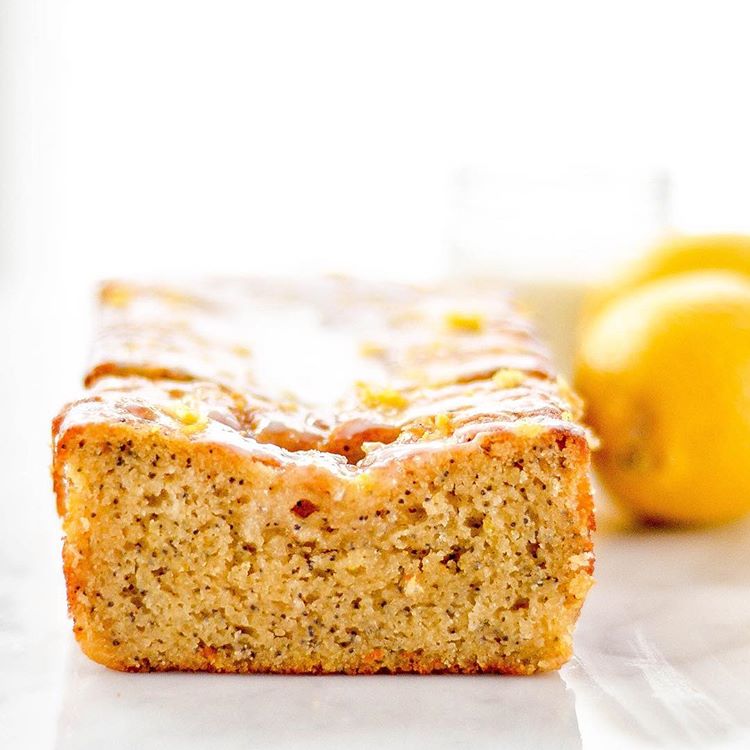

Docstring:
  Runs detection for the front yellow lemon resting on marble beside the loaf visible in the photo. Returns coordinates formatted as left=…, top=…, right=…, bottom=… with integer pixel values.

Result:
left=576, top=272, right=750, bottom=524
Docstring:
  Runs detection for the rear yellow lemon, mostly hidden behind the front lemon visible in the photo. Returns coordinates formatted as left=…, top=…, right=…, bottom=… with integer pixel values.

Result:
left=582, top=234, right=750, bottom=326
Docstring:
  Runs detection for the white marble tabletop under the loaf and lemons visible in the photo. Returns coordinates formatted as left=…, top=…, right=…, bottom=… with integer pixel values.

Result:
left=0, top=284, right=750, bottom=750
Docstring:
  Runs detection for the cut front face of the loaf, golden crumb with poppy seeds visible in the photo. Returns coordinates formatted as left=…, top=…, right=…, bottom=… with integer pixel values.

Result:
left=54, top=424, right=593, bottom=674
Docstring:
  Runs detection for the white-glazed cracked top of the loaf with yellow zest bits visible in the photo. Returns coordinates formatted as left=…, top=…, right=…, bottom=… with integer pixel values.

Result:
left=53, top=277, right=584, bottom=472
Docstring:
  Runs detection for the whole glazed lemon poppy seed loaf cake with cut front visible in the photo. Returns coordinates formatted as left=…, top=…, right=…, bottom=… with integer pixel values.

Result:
left=53, top=277, right=594, bottom=674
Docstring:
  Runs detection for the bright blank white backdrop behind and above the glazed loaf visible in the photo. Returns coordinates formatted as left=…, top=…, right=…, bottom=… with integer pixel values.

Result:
left=0, top=0, right=750, bottom=278
